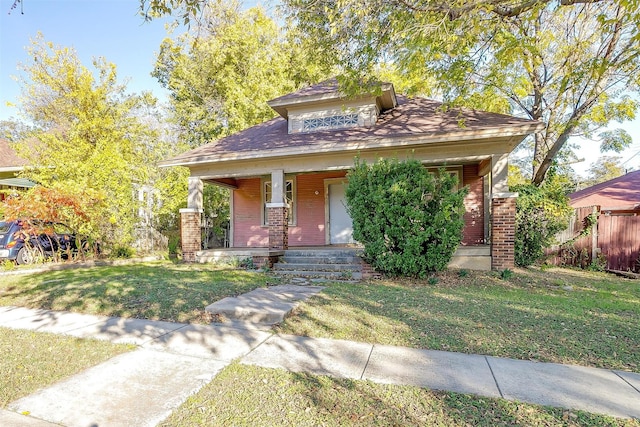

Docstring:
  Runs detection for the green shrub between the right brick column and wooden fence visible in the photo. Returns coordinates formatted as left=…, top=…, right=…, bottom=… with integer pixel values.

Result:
left=511, top=178, right=572, bottom=267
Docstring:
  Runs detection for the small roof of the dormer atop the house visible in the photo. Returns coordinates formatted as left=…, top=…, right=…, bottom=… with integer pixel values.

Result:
left=267, top=78, right=397, bottom=119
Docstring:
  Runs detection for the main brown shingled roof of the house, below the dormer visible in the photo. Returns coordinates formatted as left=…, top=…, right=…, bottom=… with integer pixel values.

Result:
left=160, top=92, right=544, bottom=166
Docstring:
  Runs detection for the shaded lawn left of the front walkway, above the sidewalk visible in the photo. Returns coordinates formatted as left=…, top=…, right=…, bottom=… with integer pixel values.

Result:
left=0, top=262, right=268, bottom=323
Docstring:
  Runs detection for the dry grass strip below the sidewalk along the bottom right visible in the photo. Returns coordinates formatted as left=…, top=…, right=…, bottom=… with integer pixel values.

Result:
left=161, top=364, right=640, bottom=427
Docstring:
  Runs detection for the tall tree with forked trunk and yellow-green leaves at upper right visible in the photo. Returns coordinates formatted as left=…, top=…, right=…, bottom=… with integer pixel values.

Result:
left=284, top=0, right=640, bottom=185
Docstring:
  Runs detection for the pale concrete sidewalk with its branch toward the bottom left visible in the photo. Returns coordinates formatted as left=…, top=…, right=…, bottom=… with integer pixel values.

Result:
left=0, top=307, right=640, bottom=427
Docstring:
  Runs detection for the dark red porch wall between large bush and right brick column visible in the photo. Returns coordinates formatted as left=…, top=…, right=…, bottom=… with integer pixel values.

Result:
left=462, top=165, right=484, bottom=245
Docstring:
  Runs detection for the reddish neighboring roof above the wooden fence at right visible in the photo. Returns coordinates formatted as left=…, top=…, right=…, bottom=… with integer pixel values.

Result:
left=569, top=170, right=640, bottom=209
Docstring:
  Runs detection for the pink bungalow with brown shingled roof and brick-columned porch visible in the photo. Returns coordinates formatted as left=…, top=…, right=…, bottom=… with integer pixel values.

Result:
left=161, top=79, right=544, bottom=269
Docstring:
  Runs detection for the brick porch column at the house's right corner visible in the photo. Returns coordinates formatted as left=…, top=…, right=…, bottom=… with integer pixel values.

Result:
left=491, top=193, right=518, bottom=270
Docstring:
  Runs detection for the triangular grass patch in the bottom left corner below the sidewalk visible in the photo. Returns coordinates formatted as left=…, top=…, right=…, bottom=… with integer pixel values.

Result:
left=0, top=327, right=135, bottom=408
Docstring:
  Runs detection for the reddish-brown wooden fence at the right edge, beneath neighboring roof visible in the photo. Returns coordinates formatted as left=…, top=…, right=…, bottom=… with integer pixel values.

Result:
left=546, top=206, right=640, bottom=273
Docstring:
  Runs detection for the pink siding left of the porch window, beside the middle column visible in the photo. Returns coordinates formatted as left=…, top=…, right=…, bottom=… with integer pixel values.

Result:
left=233, top=178, right=269, bottom=248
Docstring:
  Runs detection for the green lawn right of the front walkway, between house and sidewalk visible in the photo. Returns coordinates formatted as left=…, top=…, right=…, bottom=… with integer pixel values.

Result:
left=278, top=269, right=640, bottom=372
